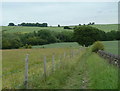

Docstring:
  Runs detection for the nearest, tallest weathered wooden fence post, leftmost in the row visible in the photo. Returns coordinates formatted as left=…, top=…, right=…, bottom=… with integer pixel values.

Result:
left=24, top=54, right=28, bottom=89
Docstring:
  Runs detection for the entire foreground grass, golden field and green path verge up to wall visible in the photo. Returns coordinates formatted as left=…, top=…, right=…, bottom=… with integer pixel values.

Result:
left=2, top=48, right=118, bottom=89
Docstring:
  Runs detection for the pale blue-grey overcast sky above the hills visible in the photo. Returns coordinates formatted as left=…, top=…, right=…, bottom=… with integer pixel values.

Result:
left=0, top=0, right=118, bottom=26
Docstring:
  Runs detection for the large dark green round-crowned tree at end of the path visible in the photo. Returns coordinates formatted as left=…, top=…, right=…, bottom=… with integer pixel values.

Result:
left=74, top=25, right=100, bottom=47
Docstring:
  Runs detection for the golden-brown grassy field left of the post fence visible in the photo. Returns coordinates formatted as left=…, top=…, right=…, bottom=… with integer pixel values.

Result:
left=2, top=48, right=80, bottom=88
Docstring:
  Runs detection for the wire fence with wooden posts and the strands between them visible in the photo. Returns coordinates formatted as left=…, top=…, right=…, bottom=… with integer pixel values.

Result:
left=1, top=48, right=84, bottom=89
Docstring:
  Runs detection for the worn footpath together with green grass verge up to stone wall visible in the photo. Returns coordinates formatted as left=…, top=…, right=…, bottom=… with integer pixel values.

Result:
left=63, top=51, right=118, bottom=89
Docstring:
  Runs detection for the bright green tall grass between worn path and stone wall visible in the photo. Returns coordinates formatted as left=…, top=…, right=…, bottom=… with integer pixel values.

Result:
left=87, top=53, right=118, bottom=89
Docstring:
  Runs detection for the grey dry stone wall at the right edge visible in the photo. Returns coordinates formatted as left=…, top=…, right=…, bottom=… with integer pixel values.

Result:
left=98, top=50, right=120, bottom=67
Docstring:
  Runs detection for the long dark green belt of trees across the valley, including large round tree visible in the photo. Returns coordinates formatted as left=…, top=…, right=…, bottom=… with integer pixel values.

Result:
left=2, top=25, right=120, bottom=49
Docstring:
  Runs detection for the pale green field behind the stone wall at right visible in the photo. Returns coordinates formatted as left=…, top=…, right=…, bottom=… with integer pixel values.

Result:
left=103, top=41, right=118, bottom=54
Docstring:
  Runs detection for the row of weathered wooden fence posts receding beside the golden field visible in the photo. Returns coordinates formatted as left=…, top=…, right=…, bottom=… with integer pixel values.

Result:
left=2, top=50, right=83, bottom=89
